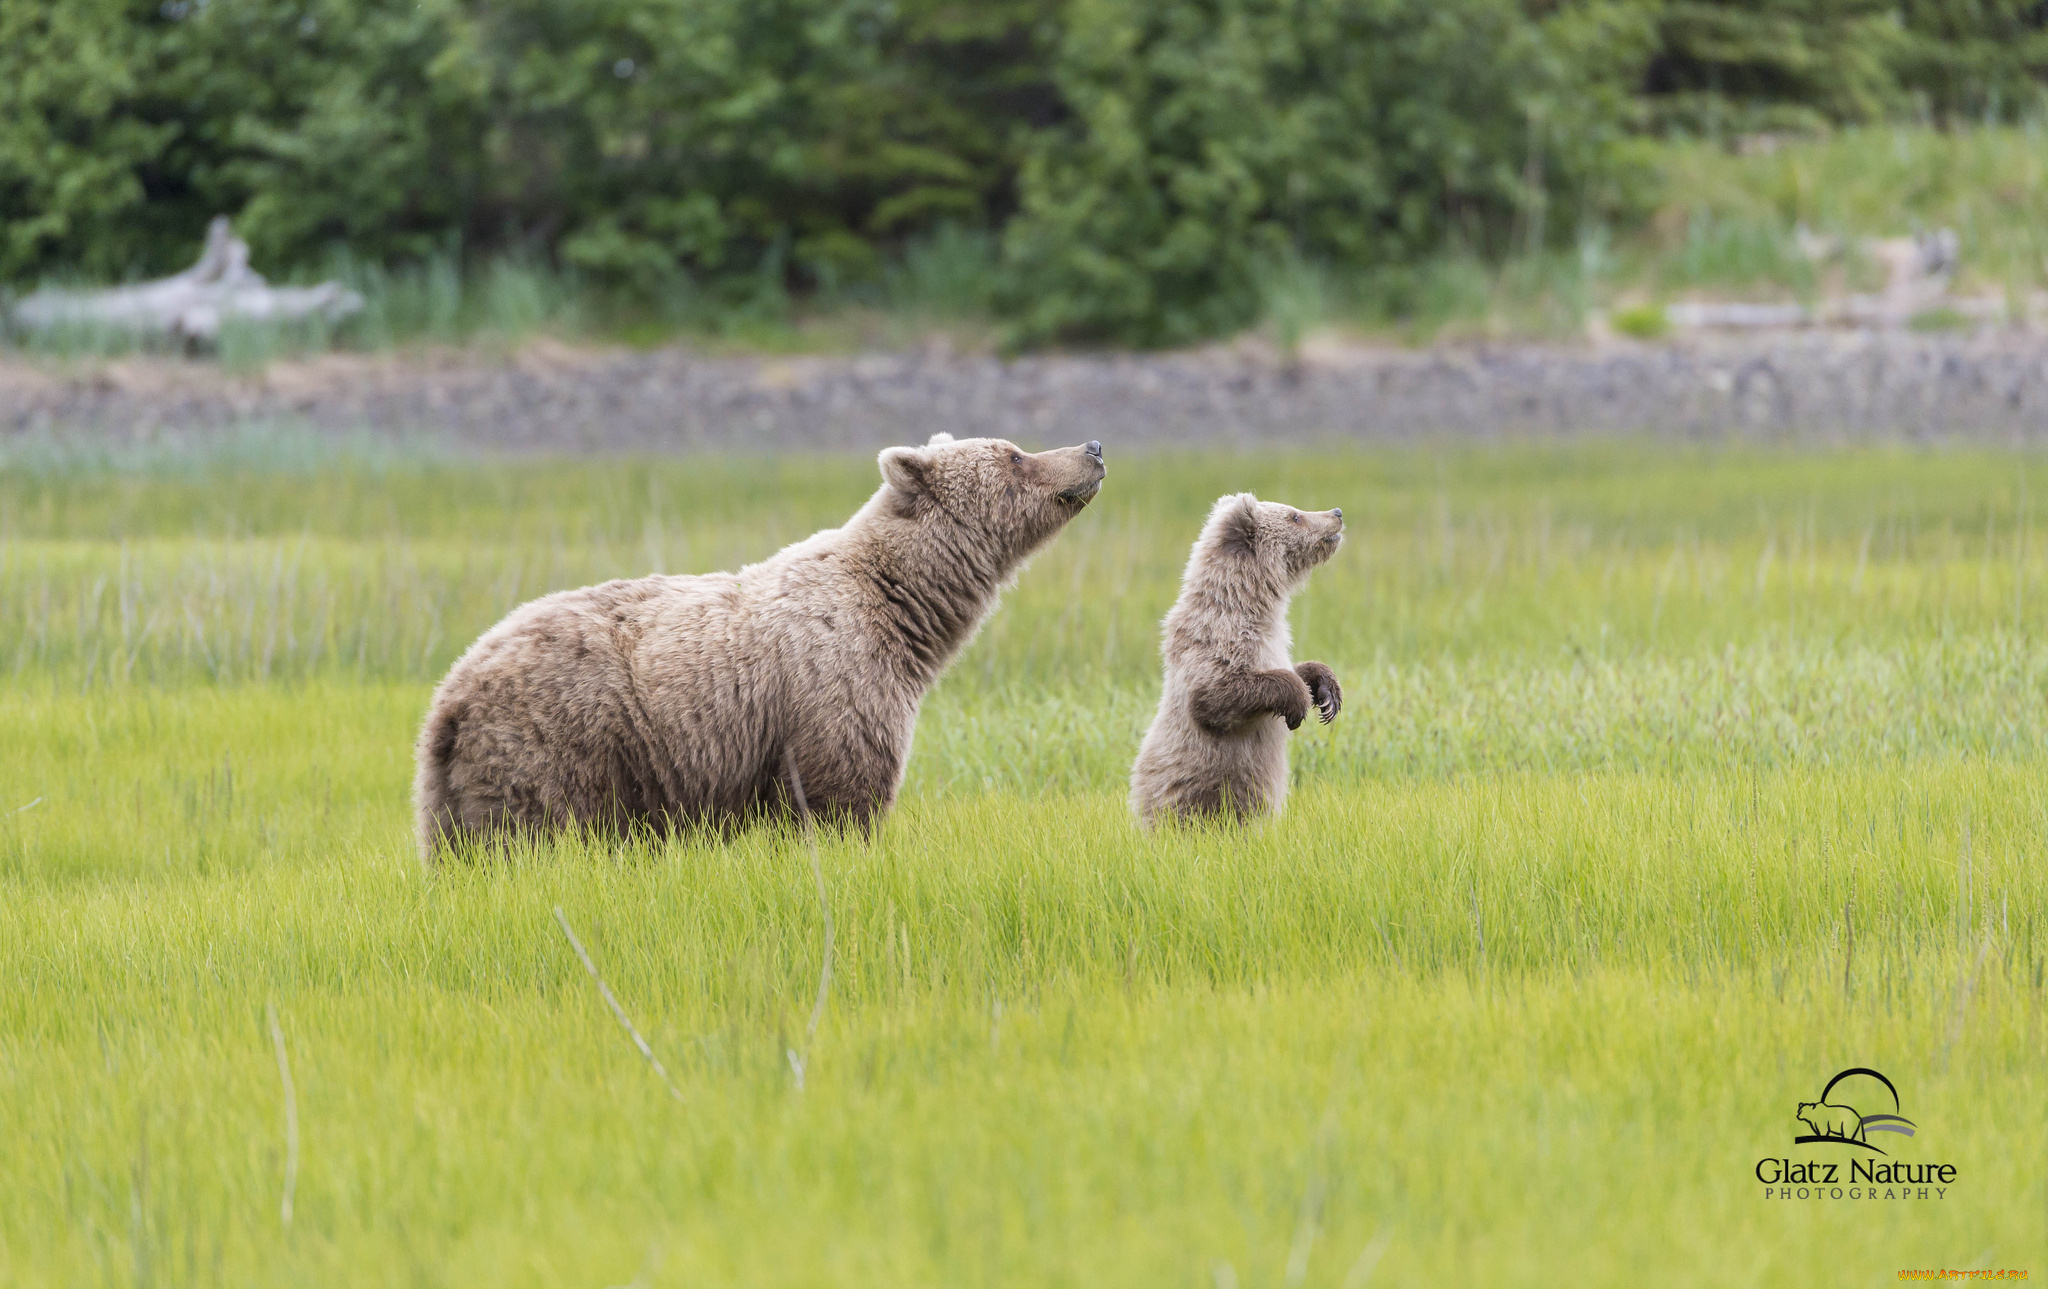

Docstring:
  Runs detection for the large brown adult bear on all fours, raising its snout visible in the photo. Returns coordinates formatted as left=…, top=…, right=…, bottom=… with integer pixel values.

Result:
left=414, top=434, right=1104, bottom=857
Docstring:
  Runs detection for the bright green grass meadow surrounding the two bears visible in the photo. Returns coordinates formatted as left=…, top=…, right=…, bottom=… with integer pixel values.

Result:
left=0, top=436, right=2048, bottom=1289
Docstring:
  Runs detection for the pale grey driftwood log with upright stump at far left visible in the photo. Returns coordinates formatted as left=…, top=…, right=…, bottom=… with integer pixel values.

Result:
left=14, top=215, right=362, bottom=340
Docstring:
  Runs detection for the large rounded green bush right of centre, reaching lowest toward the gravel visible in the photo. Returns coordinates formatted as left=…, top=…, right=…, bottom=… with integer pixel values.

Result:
left=1006, top=0, right=1654, bottom=344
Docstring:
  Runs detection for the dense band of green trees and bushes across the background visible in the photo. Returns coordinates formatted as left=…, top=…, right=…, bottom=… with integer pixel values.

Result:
left=0, top=0, right=2048, bottom=344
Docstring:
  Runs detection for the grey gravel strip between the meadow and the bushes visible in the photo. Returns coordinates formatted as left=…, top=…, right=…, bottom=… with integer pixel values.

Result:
left=0, top=332, right=2048, bottom=453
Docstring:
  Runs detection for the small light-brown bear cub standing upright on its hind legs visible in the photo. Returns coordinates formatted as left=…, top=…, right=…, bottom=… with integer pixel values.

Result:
left=1130, top=492, right=1343, bottom=824
